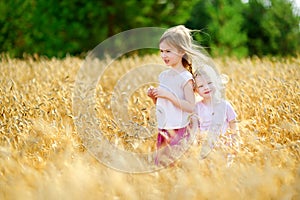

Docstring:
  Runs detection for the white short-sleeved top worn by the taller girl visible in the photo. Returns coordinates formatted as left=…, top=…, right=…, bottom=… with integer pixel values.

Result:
left=156, top=69, right=193, bottom=129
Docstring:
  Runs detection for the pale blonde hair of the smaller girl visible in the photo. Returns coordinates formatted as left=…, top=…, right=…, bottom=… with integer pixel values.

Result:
left=194, top=65, right=228, bottom=101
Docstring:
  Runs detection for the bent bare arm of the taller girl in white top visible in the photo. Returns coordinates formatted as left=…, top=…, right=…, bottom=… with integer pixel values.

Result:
left=153, top=80, right=195, bottom=113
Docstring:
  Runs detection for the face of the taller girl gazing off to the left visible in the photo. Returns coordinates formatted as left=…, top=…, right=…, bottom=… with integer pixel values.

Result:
left=159, top=41, right=184, bottom=67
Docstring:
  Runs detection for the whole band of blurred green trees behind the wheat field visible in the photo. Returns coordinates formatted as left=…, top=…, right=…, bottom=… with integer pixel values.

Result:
left=0, top=0, right=300, bottom=58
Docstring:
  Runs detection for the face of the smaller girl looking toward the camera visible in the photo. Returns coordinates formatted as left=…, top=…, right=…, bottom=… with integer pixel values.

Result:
left=195, top=76, right=216, bottom=99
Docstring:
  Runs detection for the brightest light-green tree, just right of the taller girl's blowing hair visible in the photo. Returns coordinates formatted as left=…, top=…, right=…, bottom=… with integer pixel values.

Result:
left=208, top=0, right=248, bottom=57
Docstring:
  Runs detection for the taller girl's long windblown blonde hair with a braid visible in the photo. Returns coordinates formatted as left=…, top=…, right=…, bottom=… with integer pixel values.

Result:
left=159, top=25, right=213, bottom=75
